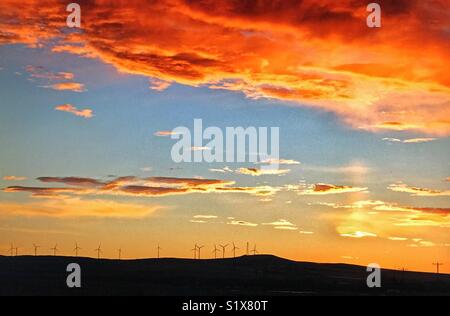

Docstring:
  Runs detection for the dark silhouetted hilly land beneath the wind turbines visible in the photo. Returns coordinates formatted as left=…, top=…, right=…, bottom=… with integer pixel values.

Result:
left=0, top=256, right=450, bottom=296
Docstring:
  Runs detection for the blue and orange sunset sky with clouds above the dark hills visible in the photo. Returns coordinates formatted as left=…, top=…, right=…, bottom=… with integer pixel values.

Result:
left=0, top=0, right=450, bottom=272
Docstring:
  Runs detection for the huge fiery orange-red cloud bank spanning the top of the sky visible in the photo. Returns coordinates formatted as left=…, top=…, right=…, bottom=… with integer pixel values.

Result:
left=0, top=0, right=450, bottom=136
